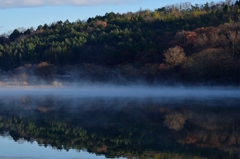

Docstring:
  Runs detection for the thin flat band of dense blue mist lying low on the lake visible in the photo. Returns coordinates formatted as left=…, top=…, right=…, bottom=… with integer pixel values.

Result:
left=0, top=84, right=240, bottom=98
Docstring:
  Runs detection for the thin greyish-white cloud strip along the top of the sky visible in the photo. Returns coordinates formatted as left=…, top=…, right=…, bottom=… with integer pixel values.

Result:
left=0, top=0, right=140, bottom=8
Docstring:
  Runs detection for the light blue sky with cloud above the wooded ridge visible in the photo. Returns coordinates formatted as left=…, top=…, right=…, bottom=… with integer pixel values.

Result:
left=0, top=0, right=213, bottom=34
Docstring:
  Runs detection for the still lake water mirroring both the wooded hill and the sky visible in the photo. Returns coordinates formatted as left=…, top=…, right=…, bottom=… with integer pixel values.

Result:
left=0, top=89, right=240, bottom=159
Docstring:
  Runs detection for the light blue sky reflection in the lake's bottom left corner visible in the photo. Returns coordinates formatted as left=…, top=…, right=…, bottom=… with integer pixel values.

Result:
left=0, top=134, right=105, bottom=159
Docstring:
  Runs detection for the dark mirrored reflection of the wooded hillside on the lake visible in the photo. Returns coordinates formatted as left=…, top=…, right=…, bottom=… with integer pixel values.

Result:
left=0, top=96, right=240, bottom=158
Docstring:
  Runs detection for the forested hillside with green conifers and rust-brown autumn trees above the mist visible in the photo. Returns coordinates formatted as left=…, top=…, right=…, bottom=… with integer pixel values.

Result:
left=0, top=0, right=240, bottom=84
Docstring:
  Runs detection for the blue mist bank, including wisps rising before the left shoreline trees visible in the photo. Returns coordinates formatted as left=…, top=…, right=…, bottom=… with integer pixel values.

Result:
left=0, top=62, right=240, bottom=100
